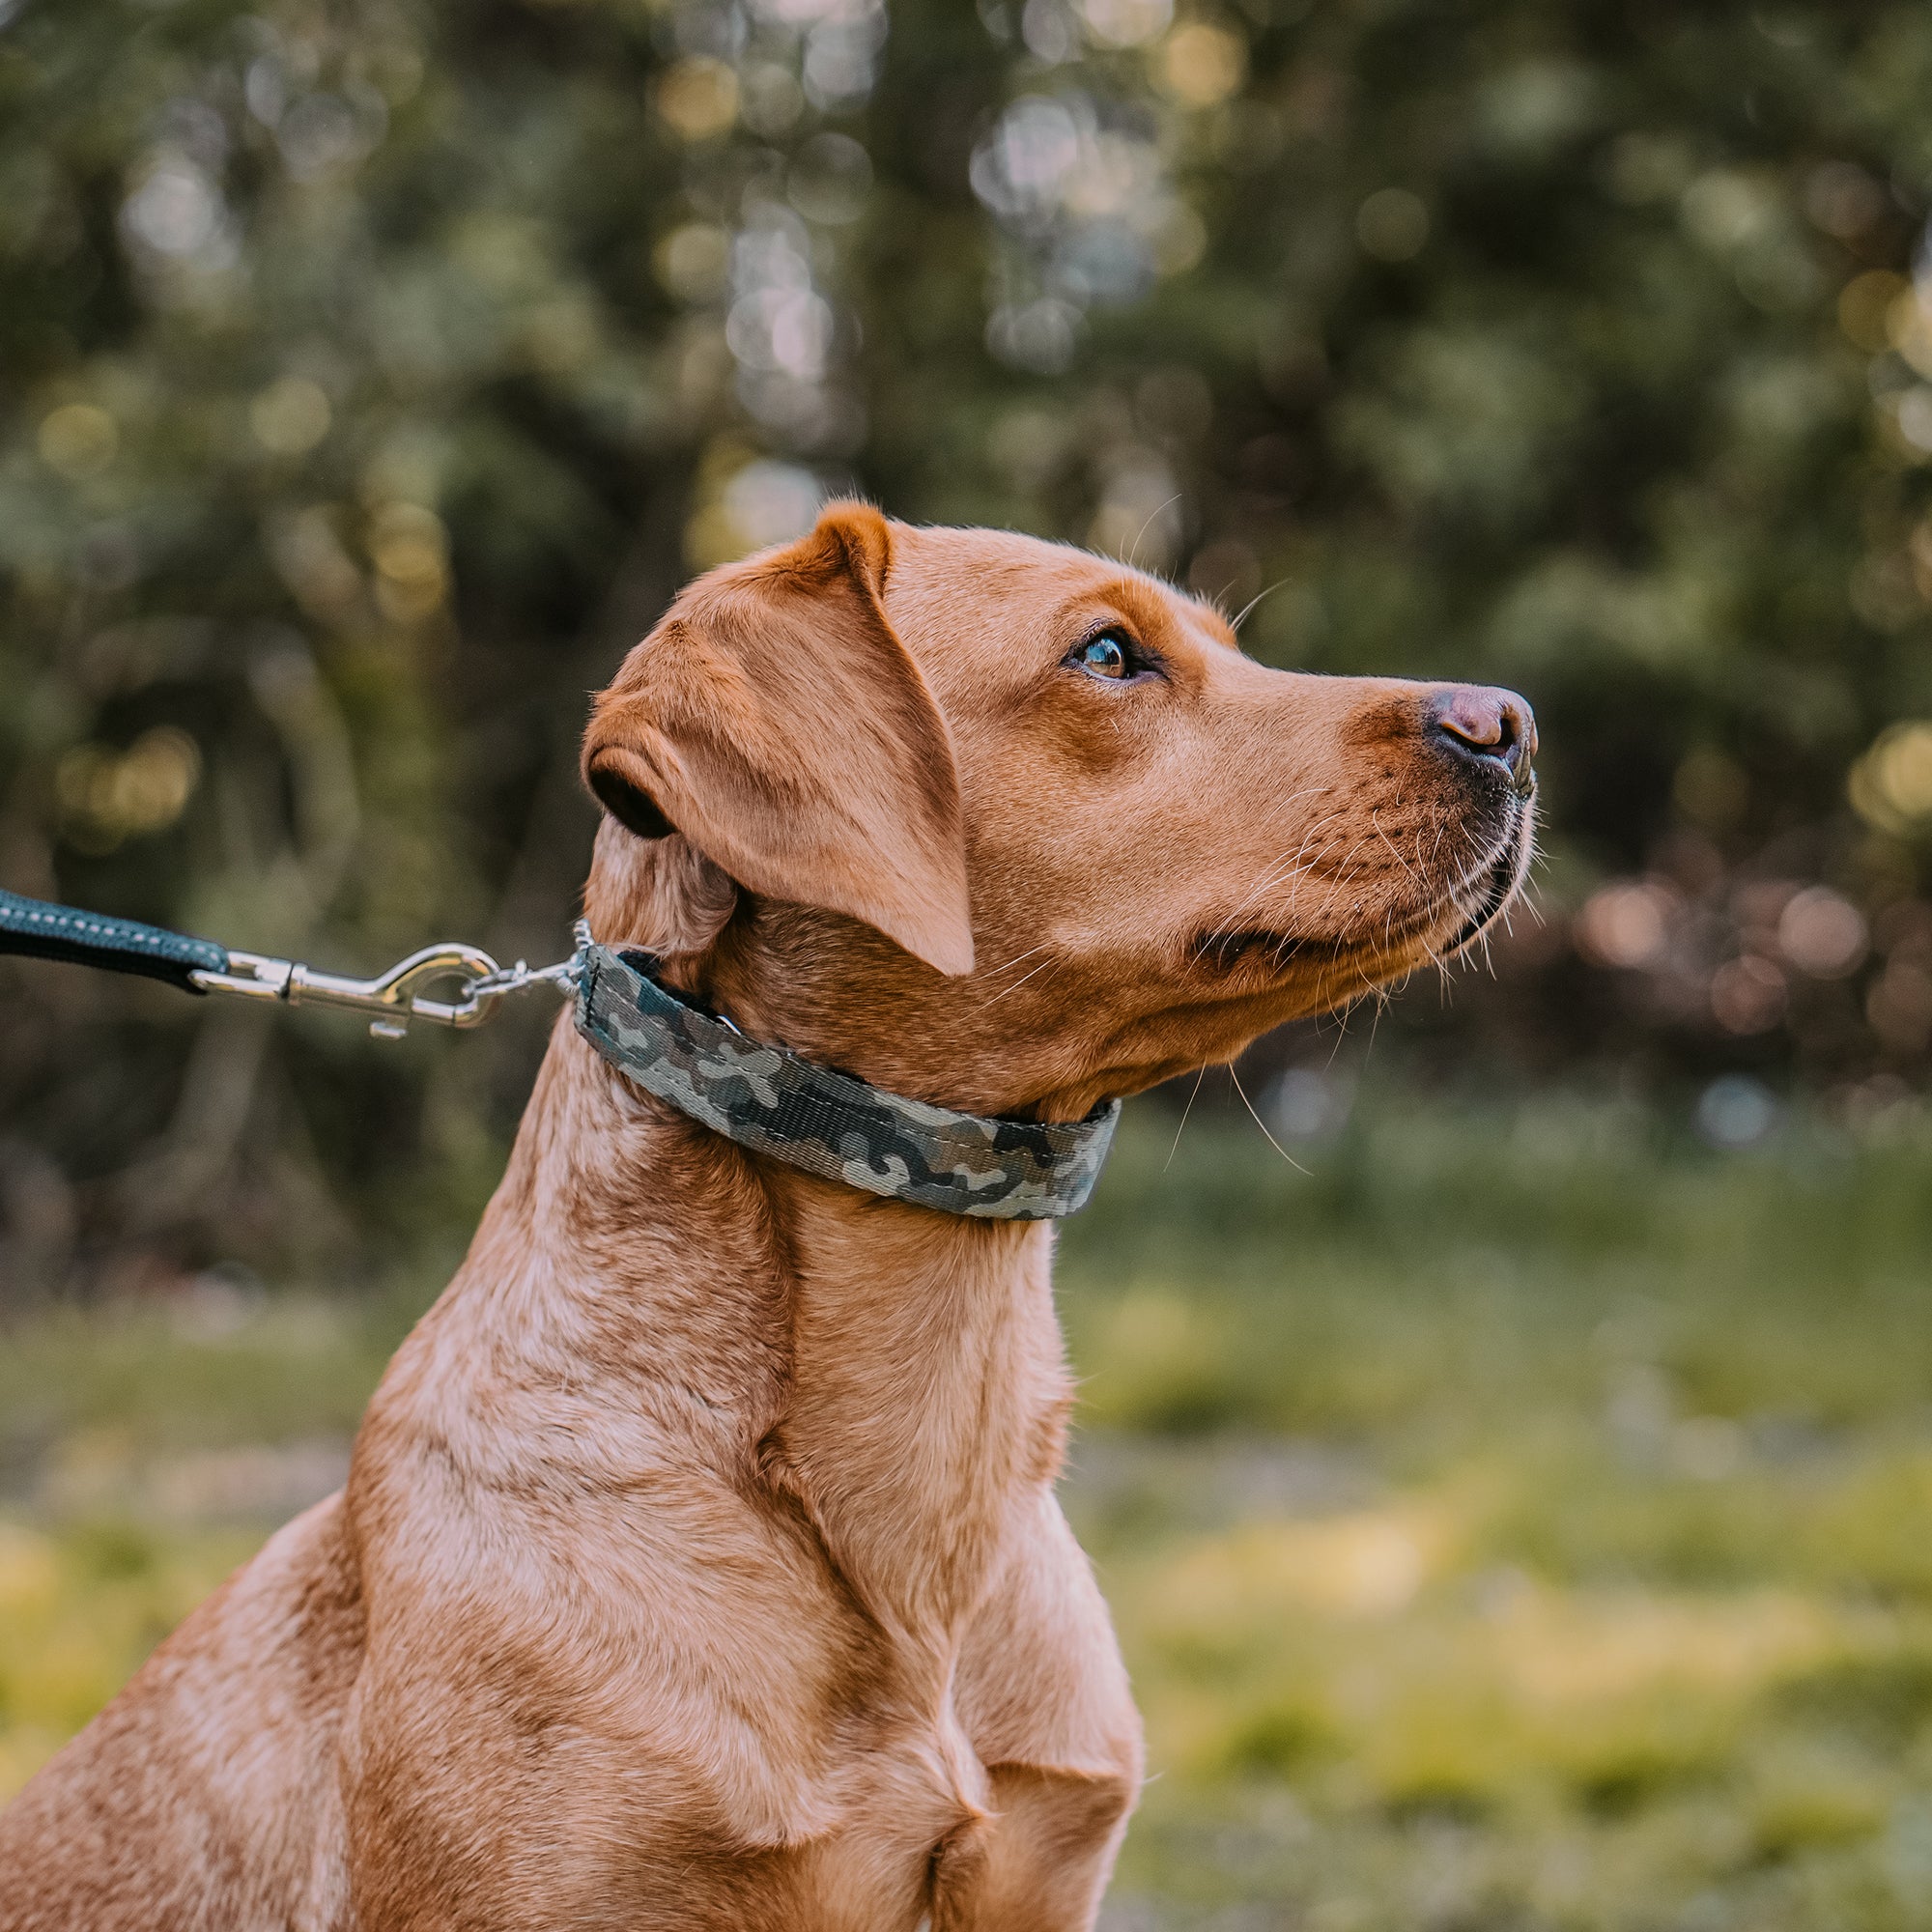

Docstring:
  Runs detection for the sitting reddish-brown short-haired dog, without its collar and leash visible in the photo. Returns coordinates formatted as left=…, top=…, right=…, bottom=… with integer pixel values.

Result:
left=0, top=502, right=1536, bottom=1932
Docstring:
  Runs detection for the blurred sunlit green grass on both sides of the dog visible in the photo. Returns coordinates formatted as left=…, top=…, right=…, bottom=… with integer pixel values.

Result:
left=11, top=1094, right=1932, bottom=1932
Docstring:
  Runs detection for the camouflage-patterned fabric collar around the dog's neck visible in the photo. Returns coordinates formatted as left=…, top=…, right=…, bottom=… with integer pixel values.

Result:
left=576, top=945, right=1121, bottom=1221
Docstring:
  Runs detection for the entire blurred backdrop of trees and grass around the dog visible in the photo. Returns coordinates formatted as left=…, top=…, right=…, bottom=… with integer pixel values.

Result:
left=11, top=0, right=1932, bottom=1932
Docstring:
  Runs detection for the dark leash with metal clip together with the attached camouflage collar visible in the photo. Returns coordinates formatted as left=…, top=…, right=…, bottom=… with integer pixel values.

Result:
left=0, top=891, right=1121, bottom=1221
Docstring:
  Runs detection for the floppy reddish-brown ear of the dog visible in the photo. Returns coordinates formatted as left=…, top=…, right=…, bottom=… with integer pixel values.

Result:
left=568, top=502, right=972, bottom=974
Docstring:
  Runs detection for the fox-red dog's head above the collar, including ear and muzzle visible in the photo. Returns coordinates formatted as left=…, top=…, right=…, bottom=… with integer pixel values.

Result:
left=583, top=504, right=1536, bottom=1119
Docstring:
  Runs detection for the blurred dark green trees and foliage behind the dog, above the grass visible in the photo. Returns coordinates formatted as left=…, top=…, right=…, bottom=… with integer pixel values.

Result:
left=0, top=0, right=1932, bottom=1300
